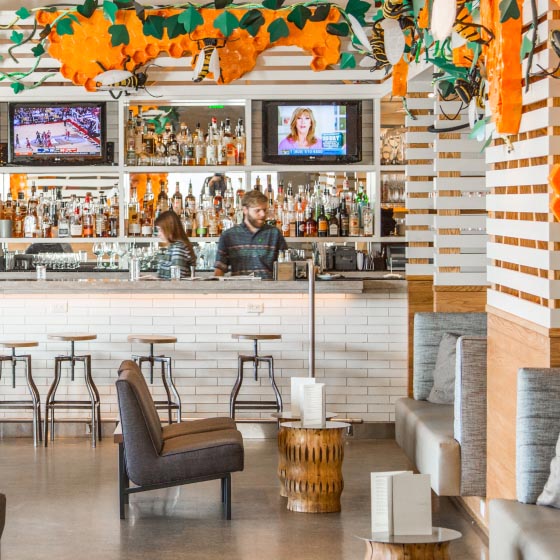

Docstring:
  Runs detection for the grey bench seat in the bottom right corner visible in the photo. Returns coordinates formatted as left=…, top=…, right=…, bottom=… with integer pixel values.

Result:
left=490, top=500, right=560, bottom=560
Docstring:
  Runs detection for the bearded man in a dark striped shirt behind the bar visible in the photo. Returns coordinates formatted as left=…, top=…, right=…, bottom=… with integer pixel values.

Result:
left=214, top=190, right=288, bottom=280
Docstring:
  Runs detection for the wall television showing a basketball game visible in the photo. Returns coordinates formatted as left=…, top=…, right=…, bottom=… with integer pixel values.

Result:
left=9, top=101, right=106, bottom=165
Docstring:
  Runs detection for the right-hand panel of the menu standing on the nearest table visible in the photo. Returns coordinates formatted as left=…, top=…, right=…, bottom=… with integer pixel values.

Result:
left=393, top=474, right=432, bottom=535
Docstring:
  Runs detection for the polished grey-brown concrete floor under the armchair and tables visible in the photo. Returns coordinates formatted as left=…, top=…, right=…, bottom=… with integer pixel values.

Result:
left=0, top=438, right=488, bottom=560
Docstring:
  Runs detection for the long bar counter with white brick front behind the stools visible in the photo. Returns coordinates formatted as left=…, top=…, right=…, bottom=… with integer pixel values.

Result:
left=0, top=271, right=408, bottom=422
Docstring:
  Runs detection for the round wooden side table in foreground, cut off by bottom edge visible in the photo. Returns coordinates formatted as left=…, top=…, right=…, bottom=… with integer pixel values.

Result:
left=358, top=527, right=462, bottom=560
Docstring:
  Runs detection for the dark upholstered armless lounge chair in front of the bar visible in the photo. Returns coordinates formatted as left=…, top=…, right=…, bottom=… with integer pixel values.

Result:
left=116, top=360, right=244, bottom=519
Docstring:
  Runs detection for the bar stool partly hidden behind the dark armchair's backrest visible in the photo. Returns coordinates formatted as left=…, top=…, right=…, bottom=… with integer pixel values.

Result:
left=127, top=334, right=181, bottom=424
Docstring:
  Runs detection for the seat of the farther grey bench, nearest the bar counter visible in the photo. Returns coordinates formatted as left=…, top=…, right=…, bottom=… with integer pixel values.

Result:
left=395, top=399, right=461, bottom=496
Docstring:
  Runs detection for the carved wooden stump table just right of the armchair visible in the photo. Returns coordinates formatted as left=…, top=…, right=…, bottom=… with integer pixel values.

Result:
left=281, top=422, right=350, bottom=513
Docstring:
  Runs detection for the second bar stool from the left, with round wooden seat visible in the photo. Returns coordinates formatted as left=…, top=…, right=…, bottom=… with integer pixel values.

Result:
left=45, top=333, right=101, bottom=447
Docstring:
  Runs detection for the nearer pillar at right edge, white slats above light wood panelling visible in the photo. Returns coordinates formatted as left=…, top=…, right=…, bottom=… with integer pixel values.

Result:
left=486, top=1, right=560, bottom=499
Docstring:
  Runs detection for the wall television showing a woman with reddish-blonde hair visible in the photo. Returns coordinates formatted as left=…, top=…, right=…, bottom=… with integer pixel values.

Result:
left=262, top=100, right=362, bottom=165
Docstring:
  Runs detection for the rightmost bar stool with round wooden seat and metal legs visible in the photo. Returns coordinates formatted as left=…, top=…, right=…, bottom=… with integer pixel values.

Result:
left=229, top=334, right=282, bottom=418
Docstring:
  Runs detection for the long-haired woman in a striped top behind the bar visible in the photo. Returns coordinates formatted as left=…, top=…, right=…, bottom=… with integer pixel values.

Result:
left=154, top=210, right=196, bottom=278
